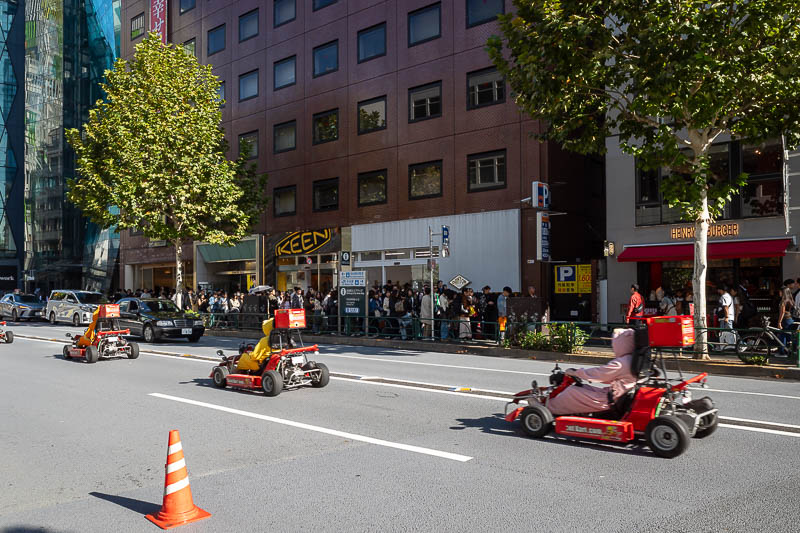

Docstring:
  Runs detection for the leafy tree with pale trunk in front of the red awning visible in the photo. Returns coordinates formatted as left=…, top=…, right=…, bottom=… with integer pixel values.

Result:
left=488, top=0, right=800, bottom=357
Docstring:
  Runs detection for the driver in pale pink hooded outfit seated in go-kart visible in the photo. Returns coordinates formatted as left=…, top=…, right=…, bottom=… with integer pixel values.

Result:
left=547, top=329, right=636, bottom=415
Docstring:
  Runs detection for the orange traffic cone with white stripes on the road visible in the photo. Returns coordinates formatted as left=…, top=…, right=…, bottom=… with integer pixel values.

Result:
left=145, top=429, right=211, bottom=529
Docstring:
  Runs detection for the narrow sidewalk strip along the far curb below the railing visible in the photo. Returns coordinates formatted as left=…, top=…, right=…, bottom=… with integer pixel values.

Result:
left=206, top=330, right=800, bottom=381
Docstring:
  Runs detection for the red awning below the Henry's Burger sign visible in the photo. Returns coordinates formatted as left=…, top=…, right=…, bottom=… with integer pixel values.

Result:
left=617, top=239, right=792, bottom=262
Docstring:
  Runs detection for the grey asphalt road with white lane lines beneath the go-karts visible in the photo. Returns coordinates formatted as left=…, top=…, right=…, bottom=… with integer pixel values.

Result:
left=0, top=324, right=800, bottom=533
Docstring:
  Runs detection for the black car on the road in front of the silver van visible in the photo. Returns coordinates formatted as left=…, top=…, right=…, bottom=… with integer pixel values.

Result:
left=117, top=298, right=206, bottom=342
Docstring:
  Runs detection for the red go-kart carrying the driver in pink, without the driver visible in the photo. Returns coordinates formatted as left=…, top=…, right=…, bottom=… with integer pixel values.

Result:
left=505, top=317, right=718, bottom=458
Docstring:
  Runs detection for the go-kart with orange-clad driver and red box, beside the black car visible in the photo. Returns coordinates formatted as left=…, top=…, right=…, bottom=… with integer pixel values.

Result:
left=63, top=304, right=139, bottom=363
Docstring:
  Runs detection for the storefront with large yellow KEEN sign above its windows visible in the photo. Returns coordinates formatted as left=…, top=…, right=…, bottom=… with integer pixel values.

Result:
left=264, top=228, right=342, bottom=293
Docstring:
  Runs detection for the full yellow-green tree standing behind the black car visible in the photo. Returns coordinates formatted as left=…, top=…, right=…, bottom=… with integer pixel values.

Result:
left=66, top=34, right=267, bottom=304
